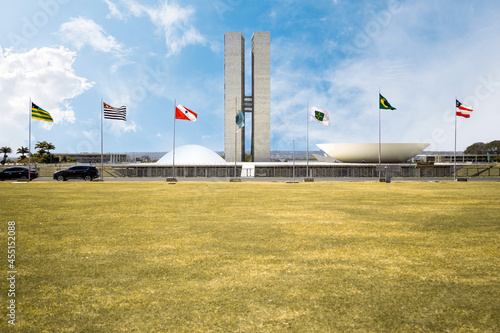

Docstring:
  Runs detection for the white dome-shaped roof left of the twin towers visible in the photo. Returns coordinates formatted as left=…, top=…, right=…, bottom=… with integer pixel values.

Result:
left=156, top=145, right=226, bottom=165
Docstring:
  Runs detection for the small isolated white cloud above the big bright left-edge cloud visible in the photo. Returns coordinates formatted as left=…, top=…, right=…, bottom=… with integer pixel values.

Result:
left=59, top=17, right=124, bottom=54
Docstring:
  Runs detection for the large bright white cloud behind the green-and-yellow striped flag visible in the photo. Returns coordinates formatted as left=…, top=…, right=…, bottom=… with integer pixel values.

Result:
left=0, top=47, right=93, bottom=151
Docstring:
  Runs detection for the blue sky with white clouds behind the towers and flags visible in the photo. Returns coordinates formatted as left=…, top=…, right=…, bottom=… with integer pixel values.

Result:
left=0, top=0, right=500, bottom=155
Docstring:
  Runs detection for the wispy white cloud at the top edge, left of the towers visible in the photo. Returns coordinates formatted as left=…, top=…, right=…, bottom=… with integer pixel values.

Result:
left=107, top=0, right=207, bottom=56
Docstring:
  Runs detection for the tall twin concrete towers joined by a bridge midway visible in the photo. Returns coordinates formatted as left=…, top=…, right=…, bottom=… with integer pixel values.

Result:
left=224, top=32, right=271, bottom=162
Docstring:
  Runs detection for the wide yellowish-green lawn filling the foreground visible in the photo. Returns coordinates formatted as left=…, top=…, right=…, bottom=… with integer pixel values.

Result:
left=0, top=182, right=500, bottom=332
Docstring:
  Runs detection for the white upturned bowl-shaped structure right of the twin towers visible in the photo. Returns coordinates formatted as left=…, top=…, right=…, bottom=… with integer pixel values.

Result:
left=316, top=143, right=430, bottom=163
